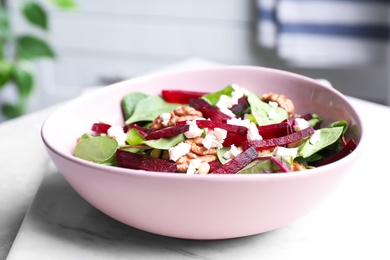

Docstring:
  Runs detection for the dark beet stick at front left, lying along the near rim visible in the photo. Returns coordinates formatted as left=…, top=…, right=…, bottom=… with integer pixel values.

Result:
left=116, top=149, right=177, bottom=172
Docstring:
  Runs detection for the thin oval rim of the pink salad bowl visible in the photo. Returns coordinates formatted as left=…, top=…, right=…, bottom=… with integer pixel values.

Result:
left=40, top=65, right=366, bottom=181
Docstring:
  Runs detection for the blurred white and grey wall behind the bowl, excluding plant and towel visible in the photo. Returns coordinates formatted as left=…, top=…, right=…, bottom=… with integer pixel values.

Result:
left=6, top=0, right=390, bottom=108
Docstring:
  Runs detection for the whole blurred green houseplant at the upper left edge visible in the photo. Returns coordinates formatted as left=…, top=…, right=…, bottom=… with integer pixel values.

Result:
left=0, top=0, right=76, bottom=118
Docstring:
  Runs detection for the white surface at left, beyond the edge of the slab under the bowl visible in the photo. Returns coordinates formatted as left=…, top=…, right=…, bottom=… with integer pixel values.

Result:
left=0, top=104, right=59, bottom=259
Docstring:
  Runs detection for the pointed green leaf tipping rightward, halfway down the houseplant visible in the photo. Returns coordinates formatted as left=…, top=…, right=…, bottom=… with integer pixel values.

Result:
left=16, top=35, right=55, bottom=60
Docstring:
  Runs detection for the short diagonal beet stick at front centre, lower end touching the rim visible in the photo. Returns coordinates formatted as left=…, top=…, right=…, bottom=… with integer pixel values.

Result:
left=211, top=146, right=259, bottom=174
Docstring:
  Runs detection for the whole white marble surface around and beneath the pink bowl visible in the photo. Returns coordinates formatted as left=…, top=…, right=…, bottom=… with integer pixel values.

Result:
left=0, top=60, right=390, bottom=260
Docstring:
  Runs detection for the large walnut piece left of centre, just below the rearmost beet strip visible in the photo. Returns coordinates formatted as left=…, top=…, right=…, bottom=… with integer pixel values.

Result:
left=150, top=106, right=203, bottom=130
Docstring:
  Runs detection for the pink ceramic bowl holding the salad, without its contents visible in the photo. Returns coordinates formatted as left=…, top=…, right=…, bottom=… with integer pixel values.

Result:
left=42, top=66, right=363, bottom=239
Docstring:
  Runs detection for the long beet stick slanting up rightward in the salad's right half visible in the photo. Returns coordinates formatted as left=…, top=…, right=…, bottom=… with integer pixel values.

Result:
left=242, top=126, right=314, bottom=151
